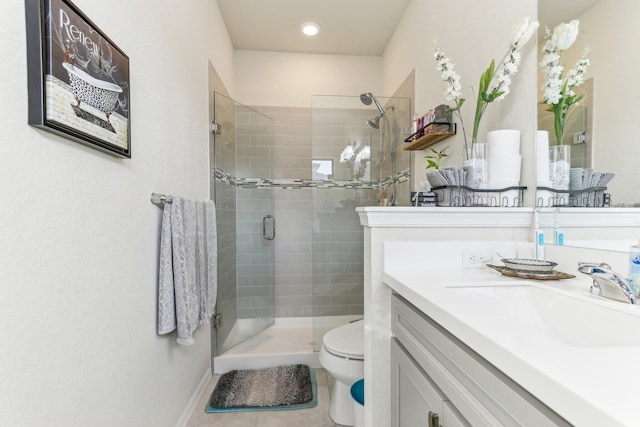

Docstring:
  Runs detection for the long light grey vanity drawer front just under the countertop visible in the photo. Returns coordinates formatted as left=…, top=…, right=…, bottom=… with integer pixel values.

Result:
left=391, top=294, right=570, bottom=427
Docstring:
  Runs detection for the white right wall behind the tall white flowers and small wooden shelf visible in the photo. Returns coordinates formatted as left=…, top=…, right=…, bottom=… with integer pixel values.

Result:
left=382, top=0, right=537, bottom=199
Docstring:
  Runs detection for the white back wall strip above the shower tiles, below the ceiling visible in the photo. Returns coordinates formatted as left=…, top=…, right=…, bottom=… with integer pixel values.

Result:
left=234, top=50, right=382, bottom=108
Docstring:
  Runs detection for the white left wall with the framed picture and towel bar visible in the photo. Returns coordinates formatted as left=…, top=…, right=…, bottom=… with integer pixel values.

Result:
left=0, top=0, right=233, bottom=427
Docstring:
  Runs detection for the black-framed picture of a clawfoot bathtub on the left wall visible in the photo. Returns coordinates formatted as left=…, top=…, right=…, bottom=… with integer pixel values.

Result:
left=25, top=0, right=131, bottom=158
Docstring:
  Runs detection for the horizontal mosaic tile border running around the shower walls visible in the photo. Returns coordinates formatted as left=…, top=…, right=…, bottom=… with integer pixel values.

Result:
left=213, top=168, right=411, bottom=190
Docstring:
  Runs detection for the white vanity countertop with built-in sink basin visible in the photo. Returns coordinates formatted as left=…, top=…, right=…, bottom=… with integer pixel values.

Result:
left=383, top=268, right=640, bottom=426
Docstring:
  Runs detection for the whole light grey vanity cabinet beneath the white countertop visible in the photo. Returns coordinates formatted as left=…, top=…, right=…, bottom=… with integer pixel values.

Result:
left=391, top=293, right=570, bottom=427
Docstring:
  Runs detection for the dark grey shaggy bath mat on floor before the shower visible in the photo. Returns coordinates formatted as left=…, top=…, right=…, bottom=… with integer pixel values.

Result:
left=205, top=365, right=318, bottom=412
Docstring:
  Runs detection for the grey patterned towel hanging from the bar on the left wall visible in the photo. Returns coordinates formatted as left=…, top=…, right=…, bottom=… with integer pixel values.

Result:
left=158, top=197, right=217, bottom=345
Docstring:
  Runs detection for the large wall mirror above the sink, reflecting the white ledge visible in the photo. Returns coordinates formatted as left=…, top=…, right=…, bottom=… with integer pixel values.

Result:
left=536, top=0, right=640, bottom=251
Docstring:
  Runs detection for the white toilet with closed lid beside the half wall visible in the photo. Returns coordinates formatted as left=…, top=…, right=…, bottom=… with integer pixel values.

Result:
left=318, top=320, right=364, bottom=426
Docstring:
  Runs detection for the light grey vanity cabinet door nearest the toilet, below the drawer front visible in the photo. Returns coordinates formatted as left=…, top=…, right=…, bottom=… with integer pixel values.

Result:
left=391, top=338, right=444, bottom=427
